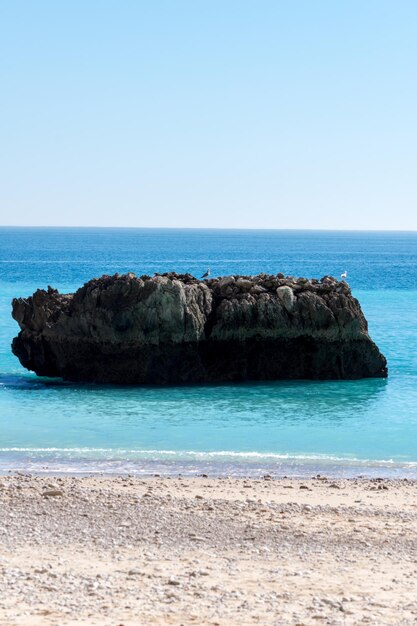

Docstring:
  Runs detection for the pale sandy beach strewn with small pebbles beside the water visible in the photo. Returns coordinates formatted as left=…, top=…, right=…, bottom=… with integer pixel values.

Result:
left=0, top=474, right=417, bottom=626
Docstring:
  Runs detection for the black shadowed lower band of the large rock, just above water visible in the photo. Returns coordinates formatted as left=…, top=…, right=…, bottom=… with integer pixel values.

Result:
left=13, top=333, right=386, bottom=385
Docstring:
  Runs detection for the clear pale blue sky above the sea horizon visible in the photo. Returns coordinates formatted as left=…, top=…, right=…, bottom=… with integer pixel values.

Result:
left=0, top=0, right=417, bottom=230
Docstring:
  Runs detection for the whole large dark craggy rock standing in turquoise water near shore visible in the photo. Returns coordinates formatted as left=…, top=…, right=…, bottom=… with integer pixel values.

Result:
left=12, top=273, right=387, bottom=384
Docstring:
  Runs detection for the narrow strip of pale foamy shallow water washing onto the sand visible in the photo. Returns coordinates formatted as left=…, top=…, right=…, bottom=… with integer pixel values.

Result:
left=0, top=451, right=417, bottom=480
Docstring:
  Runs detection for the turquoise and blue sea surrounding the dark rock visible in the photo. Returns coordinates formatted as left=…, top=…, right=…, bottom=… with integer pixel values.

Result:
left=0, top=228, right=417, bottom=477
